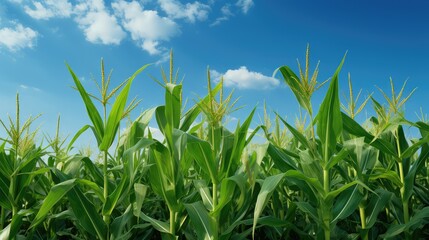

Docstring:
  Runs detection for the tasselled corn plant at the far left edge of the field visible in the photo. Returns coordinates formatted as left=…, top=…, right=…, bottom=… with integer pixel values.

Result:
left=0, top=94, right=45, bottom=239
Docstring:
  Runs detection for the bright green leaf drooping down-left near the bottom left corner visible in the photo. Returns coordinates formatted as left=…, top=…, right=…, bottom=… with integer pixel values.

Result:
left=30, top=179, right=76, bottom=228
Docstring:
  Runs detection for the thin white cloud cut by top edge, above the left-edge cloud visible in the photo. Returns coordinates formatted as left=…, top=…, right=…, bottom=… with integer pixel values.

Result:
left=24, top=0, right=72, bottom=20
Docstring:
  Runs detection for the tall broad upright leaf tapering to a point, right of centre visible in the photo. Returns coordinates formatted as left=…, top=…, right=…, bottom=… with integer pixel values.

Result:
left=317, top=56, right=345, bottom=159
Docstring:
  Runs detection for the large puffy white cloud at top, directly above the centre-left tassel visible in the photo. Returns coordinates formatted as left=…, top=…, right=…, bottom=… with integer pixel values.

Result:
left=112, top=0, right=180, bottom=54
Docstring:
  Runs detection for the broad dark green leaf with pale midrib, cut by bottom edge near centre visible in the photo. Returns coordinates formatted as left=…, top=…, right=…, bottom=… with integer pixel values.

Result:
left=185, top=202, right=218, bottom=239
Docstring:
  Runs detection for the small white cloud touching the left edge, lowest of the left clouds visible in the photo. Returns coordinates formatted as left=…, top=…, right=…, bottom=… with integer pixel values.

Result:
left=0, top=23, right=38, bottom=52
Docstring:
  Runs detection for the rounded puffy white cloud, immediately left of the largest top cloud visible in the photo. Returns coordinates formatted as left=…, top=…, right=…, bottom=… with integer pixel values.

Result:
left=75, top=0, right=126, bottom=45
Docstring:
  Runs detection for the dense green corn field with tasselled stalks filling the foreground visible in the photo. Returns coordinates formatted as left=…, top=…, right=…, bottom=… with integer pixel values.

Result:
left=0, top=48, right=429, bottom=240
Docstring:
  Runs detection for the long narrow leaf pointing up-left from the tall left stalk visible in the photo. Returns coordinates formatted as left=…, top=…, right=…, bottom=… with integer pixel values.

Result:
left=66, top=63, right=104, bottom=144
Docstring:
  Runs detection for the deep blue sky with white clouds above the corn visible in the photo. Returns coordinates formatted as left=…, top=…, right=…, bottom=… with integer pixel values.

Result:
left=0, top=0, right=429, bottom=144
